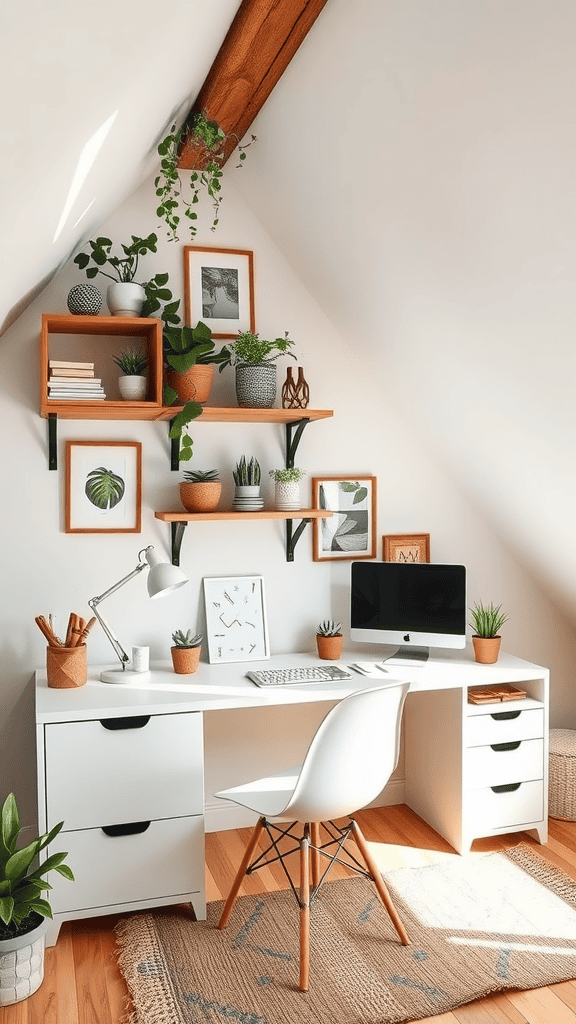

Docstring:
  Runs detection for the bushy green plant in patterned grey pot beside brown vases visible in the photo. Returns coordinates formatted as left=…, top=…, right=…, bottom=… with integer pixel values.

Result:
left=218, top=331, right=296, bottom=409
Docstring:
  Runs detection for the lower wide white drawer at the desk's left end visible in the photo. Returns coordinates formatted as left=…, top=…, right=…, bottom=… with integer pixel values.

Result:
left=50, top=815, right=204, bottom=913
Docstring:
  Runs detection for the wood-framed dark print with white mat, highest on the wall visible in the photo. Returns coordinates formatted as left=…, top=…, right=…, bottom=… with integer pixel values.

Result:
left=184, top=246, right=256, bottom=338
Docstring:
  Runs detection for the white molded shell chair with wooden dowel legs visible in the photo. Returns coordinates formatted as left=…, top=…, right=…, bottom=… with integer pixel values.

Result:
left=215, top=682, right=409, bottom=991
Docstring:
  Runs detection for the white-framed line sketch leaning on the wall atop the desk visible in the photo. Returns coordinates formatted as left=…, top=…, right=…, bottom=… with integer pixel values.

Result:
left=203, top=577, right=270, bottom=665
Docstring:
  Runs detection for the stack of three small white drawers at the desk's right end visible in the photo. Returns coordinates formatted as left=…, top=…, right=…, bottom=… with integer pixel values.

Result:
left=465, top=698, right=546, bottom=836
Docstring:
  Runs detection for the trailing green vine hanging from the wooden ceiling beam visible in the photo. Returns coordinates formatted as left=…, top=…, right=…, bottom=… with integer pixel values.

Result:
left=154, top=113, right=256, bottom=242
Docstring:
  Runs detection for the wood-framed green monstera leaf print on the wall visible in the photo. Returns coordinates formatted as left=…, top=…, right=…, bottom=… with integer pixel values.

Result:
left=66, top=441, right=141, bottom=534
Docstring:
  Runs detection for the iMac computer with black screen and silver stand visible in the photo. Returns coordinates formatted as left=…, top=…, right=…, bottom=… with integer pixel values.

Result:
left=351, top=561, right=466, bottom=662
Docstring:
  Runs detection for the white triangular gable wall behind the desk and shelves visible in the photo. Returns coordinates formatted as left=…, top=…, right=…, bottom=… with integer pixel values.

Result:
left=0, top=161, right=576, bottom=821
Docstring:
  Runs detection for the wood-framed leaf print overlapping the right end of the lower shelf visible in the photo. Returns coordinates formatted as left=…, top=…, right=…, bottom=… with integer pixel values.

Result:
left=312, top=476, right=376, bottom=562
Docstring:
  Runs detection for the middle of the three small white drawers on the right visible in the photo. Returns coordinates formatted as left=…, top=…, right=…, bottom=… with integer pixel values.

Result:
left=464, top=739, right=544, bottom=790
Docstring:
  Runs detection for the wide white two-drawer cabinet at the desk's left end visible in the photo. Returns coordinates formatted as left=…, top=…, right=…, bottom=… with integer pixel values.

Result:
left=38, top=712, right=205, bottom=945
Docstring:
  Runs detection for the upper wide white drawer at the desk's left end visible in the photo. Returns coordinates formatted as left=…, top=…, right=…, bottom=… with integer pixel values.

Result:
left=45, top=712, right=204, bottom=831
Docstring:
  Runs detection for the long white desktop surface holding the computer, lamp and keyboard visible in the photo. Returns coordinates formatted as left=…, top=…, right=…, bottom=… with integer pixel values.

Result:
left=36, top=644, right=548, bottom=723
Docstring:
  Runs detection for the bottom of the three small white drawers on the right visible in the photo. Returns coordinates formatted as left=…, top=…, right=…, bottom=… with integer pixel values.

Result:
left=465, top=780, right=544, bottom=836
